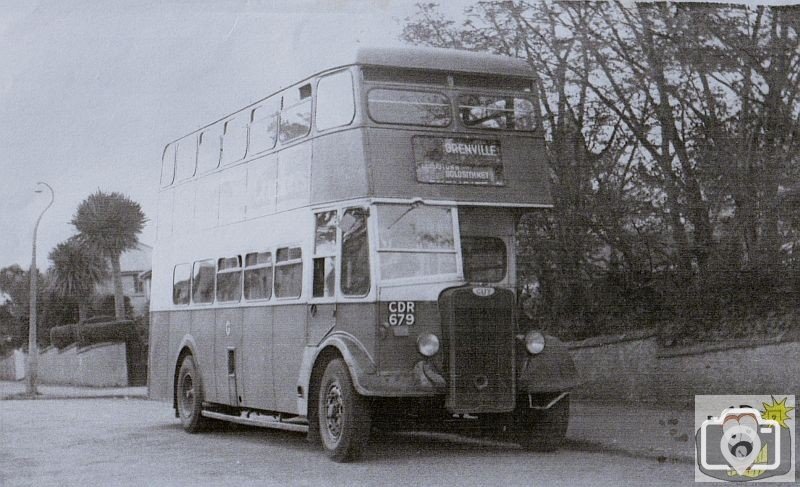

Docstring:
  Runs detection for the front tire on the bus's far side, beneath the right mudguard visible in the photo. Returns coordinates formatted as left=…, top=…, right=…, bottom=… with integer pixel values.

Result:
left=514, top=395, right=569, bottom=452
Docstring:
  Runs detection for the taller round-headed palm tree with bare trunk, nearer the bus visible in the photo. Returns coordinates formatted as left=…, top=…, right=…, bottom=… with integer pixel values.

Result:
left=72, top=190, right=147, bottom=320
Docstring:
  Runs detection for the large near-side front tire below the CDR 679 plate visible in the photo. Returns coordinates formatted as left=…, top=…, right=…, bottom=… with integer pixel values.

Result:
left=317, top=359, right=371, bottom=462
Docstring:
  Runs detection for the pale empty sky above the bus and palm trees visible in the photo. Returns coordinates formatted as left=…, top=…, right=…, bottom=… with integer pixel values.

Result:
left=0, top=0, right=468, bottom=268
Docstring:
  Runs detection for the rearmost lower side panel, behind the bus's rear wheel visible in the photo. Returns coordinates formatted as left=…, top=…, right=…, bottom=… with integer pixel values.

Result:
left=147, top=311, right=175, bottom=401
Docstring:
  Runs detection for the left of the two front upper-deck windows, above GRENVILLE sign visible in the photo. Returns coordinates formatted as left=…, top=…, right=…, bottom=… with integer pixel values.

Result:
left=367, top=88, right=453, bottom=127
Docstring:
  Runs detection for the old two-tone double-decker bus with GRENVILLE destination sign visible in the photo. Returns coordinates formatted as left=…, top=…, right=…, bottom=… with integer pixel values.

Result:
left=148, top=48, right=578, bottom=461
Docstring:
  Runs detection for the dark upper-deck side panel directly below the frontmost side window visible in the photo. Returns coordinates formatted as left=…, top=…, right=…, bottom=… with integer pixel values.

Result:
left=311, top=130, right=368, bottom=203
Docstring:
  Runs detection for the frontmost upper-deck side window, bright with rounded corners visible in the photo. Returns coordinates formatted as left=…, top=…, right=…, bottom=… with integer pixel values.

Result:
left=316, top=71, right=356, bottom=130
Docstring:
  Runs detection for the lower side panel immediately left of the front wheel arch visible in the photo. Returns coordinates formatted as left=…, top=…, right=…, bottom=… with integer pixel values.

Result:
left=272, top=304, right=307, bottom=414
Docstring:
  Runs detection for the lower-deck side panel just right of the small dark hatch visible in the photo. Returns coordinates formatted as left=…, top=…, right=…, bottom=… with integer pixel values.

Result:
left=241, top=306, right=275, bottom=411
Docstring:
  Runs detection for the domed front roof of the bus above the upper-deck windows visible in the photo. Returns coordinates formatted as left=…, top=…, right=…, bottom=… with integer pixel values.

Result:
left=352, top=47, right=534, bottom=78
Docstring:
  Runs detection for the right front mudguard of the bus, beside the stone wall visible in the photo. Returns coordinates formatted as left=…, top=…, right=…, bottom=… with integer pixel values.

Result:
left=516, top=335, right=581, bottom=393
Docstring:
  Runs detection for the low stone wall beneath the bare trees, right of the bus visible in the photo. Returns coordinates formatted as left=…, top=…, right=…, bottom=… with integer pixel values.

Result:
left=568, top=331, right=800, bottom=407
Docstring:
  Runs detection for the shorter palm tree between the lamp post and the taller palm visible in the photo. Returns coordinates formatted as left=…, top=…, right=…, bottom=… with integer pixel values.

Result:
left=49, top=237, right=108, bottom=321
